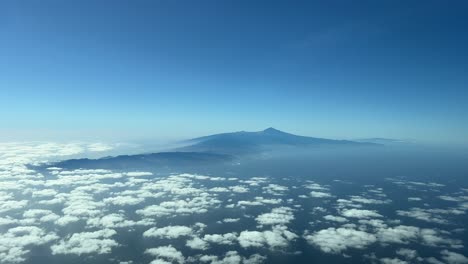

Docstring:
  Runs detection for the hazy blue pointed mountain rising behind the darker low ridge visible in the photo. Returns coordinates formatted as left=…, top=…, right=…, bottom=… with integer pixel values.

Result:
left=177, top=127, right=377, bottom=155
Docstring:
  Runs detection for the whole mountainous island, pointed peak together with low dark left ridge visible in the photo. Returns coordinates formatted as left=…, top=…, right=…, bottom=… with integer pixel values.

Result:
left=46, top=128, right=379, bottom=169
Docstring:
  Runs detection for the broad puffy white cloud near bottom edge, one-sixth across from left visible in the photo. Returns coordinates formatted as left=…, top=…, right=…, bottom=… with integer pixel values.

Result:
left=50, top=229, right=119, bottom=255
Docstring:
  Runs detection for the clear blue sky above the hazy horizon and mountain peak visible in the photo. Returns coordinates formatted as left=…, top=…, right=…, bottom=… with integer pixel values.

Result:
left=0, top=0, right=468, bottom=143
